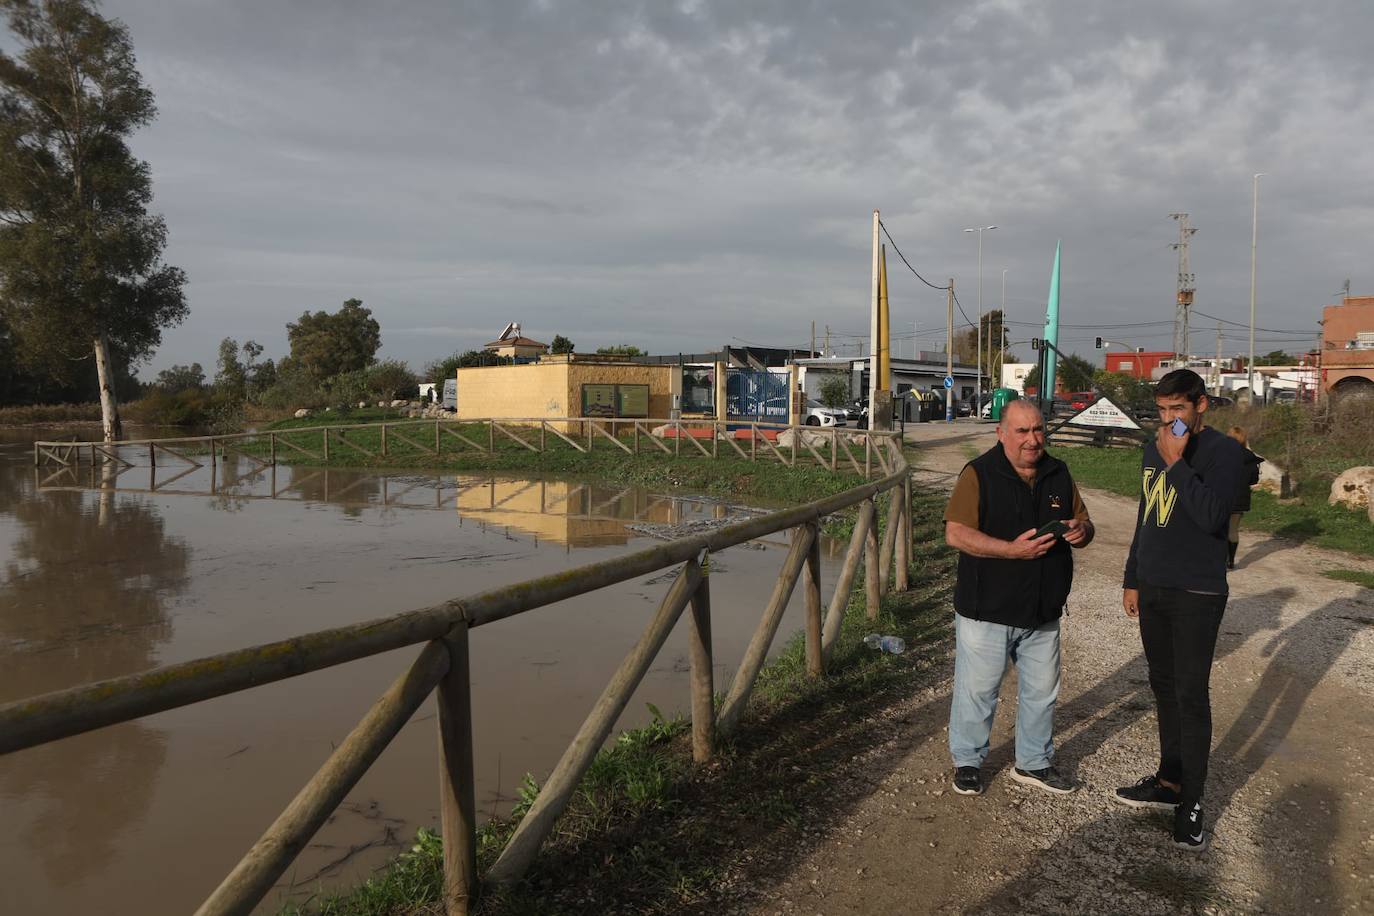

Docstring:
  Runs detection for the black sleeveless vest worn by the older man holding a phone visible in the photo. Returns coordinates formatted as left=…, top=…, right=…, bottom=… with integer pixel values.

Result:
left=954, top=442, right=1073, bottom=629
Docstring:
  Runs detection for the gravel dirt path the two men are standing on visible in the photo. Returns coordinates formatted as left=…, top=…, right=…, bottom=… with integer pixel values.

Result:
left=756, top=423, right=1374, bottom=915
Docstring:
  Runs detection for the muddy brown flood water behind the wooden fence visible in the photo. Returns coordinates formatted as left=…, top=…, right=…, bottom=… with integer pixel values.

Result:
left=0, top=431, right=840, bottom=916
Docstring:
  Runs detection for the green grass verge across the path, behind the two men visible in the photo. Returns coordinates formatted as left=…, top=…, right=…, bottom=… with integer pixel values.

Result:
left=1054, top=446, right=1374, bottom=556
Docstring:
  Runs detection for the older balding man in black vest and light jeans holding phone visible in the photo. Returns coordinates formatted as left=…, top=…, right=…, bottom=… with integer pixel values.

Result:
left=945, top=401, right=1092, bottom=795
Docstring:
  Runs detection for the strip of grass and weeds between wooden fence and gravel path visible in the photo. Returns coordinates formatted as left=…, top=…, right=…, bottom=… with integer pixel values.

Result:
left=286, top=490, right=956, bottom=916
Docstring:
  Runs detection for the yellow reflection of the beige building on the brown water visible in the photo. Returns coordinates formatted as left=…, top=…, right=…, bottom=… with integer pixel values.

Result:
left=458, top=479, right=725, bottom=547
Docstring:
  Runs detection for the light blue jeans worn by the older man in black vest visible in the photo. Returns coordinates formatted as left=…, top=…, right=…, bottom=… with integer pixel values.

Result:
left=949, top=614, right=1059, bottom=770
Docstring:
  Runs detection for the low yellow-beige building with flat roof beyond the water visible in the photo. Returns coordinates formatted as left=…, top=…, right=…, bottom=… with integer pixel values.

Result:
left=456, top=354, right=682, bottom=431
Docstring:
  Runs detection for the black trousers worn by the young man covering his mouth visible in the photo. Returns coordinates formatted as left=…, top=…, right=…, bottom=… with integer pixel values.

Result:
left=1140, top=585, right=1226, bottom=805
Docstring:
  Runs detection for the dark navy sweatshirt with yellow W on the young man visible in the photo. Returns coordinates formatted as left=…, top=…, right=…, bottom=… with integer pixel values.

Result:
left=1123, top=426, right=1245, bottom=595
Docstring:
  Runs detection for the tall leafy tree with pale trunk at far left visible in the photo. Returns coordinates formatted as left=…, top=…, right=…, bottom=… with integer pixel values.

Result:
left=0, top=0, right=188, bottom=441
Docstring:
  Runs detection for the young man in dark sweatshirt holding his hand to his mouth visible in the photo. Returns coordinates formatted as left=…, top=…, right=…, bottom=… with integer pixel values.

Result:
left=1114, top=369, right=1242, bottom=851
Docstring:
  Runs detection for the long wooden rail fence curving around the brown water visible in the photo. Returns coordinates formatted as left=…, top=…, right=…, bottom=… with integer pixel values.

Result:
left=13, top=417, right=911, bottom=916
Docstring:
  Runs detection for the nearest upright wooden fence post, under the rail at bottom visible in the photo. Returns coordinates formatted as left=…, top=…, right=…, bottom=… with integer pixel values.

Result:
left=445, top=621, right=477, bottom=916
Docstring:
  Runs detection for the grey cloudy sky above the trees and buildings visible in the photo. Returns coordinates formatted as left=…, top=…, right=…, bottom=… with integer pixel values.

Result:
left=75, top=0, right=1374, bottom=375
